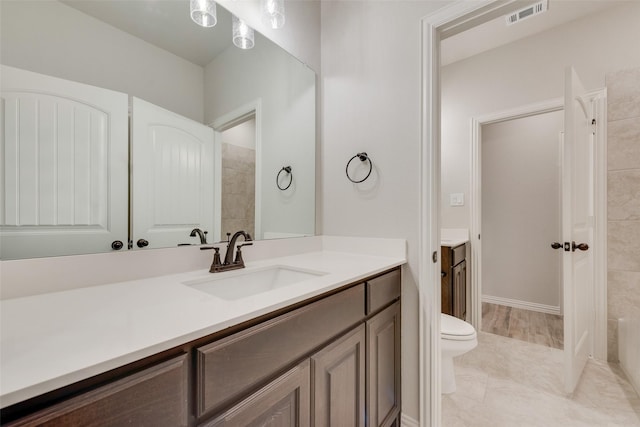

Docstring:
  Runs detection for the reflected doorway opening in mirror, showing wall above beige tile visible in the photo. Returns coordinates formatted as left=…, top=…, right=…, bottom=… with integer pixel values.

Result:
left=221, top=113, right=256, bottom=238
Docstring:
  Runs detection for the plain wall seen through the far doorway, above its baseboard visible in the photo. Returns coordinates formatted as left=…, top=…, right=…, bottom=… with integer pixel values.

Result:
left=481, top=111, right=564, bottom=310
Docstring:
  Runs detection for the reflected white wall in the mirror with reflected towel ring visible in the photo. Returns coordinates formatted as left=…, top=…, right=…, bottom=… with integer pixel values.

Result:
left=205, top=39, right=316, bottom=239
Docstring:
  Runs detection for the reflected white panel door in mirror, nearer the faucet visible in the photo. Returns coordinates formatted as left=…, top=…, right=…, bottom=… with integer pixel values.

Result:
left=131, top=98, right=214, bottom=249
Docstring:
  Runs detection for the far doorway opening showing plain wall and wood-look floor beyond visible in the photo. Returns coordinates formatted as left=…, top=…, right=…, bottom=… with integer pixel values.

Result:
left=480, top=109, right=564, bottom=349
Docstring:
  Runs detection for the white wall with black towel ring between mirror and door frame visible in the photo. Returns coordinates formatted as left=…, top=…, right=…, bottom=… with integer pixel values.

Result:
left=321, top=1, right=445, bottom=420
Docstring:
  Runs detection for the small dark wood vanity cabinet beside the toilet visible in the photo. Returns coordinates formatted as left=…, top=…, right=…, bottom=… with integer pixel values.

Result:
left=441, top=243, right=467, bottom=320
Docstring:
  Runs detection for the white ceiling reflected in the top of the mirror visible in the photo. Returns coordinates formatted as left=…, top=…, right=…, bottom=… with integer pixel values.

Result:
left=61, top=0, right=235, bottom=66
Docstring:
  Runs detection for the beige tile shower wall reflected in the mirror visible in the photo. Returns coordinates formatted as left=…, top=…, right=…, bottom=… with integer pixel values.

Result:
left=220, top=143, right=256, bottom=240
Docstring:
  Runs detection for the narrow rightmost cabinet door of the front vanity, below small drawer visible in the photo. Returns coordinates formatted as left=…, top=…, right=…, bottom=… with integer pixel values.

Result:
left=367, top=302, right=400, bottom=427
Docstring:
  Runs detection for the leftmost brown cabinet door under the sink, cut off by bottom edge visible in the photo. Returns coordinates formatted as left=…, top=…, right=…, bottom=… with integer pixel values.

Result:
left=202, top=360, right=311, bottom=427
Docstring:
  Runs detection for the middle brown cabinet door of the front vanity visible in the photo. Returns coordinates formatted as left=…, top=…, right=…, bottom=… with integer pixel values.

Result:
left=311, top=324, right=366, bottom=427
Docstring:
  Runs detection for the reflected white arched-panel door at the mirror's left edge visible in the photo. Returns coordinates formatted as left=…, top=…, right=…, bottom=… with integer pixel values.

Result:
left=0, top=65, right=129, bottom=259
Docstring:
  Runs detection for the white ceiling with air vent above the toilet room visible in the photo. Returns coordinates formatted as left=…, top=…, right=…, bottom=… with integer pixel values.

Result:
left=440, top=0, right=628, bottom=65
